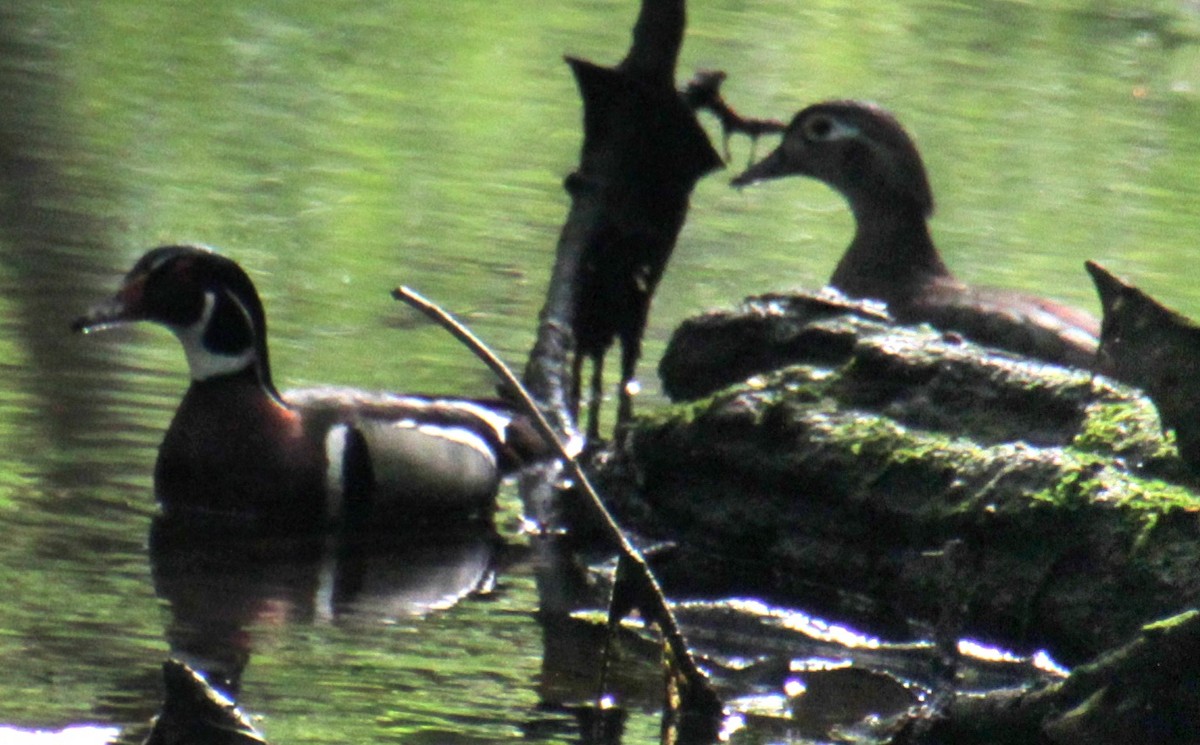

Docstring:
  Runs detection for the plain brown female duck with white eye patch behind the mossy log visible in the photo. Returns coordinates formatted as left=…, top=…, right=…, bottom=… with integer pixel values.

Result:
left=733, top=101, right=1099, bottom=368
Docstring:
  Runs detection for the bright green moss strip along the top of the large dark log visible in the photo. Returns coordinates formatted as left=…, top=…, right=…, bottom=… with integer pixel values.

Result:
left=637, top=338, right=1200, bottom=527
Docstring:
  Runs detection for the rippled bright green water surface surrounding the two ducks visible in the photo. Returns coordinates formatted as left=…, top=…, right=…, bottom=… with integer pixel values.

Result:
left=0, top=0, right=1200, bottom=743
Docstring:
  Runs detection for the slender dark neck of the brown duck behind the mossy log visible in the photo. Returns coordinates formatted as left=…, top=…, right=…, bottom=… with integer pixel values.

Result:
left=829, top=204, right=950, bottom=301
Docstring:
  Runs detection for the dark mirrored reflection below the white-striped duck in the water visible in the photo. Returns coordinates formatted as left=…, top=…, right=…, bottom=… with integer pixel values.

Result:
left=150, top=517, right=502, bottom=696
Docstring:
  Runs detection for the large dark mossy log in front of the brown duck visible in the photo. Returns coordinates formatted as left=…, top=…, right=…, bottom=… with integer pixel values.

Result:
left=604, top=289, right=1200, bottom=663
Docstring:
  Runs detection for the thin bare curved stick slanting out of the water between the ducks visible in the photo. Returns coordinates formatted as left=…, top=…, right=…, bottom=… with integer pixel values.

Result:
left=391, top=287, right=721, bottom=716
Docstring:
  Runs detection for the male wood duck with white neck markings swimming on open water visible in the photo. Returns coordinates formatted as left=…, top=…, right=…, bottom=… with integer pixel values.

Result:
left=74, top=246, right=541, bottom=528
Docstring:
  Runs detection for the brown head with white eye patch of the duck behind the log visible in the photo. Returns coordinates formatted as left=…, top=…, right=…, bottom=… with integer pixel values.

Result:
left=733, top=101, right=934, bottom=217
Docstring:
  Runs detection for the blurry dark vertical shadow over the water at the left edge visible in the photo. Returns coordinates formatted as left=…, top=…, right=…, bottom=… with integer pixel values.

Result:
left=0, top=1, right=139, bottom=487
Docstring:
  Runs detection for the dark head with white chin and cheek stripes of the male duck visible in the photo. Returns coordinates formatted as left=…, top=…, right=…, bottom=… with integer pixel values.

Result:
left=72, top=245, right=274, bottom=390
